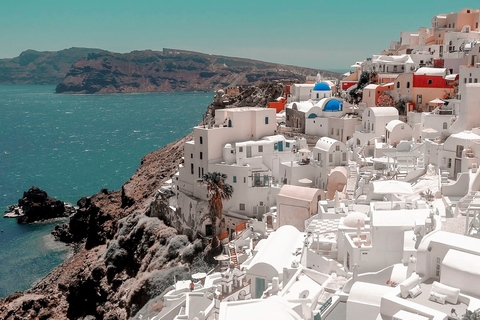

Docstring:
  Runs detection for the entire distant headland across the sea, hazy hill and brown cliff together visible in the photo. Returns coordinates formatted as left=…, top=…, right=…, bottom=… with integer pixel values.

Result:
left=0, top=48, right=340, bottom=94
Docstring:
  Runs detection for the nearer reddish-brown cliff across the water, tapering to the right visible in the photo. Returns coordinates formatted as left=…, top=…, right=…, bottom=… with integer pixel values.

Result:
left=56, top=49, right=339, bottom=93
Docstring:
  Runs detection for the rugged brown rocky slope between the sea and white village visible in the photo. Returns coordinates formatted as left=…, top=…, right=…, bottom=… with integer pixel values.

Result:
left=0, top=131, right=210, bottom=319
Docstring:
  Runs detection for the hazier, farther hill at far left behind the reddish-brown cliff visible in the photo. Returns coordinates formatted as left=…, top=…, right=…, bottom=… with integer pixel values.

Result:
left=0, top=48, right=102, bottom=84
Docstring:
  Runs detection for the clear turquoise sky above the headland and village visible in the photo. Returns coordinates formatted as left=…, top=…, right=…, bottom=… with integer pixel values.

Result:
left=0, top=0, right=480, bottom=69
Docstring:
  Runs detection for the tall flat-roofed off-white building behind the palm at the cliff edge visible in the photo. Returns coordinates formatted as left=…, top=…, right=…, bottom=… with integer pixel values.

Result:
left=176, top=108, right=278, bottom=234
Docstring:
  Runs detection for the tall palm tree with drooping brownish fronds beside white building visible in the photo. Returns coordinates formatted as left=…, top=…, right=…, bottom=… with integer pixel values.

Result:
left=199, top=172, right=233, bottom=248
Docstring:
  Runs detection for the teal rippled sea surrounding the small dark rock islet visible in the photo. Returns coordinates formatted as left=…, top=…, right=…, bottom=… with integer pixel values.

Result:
left=0, top=85, right=214, bottom=297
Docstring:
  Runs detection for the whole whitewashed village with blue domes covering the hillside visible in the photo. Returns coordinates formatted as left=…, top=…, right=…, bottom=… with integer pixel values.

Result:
left=153, top=9, right=480, bottom=320
